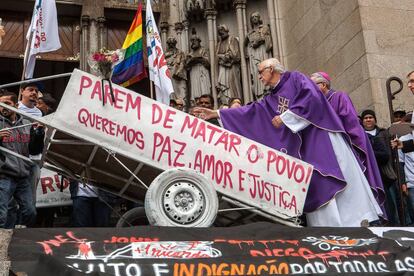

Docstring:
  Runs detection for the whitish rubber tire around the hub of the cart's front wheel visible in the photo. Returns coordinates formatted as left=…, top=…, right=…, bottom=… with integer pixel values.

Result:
left=145, top=168, right=219, bottom=227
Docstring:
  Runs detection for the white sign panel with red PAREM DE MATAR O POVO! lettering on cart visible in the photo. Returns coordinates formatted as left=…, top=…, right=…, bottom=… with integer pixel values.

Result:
left=51, top=70, right=313, bottom=218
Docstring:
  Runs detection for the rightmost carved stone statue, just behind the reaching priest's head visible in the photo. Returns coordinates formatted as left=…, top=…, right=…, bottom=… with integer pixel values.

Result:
left=245, top=12, right=273, bottom=99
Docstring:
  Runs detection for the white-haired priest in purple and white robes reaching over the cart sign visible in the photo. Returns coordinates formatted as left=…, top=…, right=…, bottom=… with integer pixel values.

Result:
left=193, top=58, right=382, bottom=226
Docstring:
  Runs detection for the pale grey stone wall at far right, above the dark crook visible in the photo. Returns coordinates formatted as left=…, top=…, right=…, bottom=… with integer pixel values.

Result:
left=358, top=0, right=414, bottom=124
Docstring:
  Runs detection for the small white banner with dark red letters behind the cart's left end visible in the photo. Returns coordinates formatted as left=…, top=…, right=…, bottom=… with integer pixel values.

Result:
left=36, top=168, right=72, bottom=208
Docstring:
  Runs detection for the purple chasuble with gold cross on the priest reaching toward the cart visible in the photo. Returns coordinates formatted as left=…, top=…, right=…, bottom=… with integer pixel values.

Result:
left=220, top=71, right=346, bottom=212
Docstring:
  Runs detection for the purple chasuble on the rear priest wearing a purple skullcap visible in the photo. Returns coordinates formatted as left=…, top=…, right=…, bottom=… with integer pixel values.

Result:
left=326, top=90, right=385, bottom=208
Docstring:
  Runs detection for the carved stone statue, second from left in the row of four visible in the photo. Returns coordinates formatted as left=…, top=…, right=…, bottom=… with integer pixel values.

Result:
left=186, top=35, right=211, bottom=103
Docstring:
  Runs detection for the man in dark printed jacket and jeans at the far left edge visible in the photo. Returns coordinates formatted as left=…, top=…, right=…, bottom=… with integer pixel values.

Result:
left=0, top=90, right=44, bottom=228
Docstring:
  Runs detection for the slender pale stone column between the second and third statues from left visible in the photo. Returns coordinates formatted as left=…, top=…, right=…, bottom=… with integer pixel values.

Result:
left=205, top=9, right=217, bottom=108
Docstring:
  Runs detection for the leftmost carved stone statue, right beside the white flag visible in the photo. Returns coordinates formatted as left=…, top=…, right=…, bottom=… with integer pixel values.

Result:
left=165, top=37, right=187, bottom=99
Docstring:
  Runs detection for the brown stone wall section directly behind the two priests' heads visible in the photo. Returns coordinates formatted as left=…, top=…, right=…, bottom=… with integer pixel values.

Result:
left=278, top=0, right=372, bottom=111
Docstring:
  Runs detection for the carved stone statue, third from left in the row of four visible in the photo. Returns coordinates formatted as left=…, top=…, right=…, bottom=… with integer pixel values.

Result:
left=216, top=25, right=242, bottom=105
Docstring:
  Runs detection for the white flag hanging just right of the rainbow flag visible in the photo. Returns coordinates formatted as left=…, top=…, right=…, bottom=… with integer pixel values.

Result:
left=145, top=0, right=174, bottom=105
